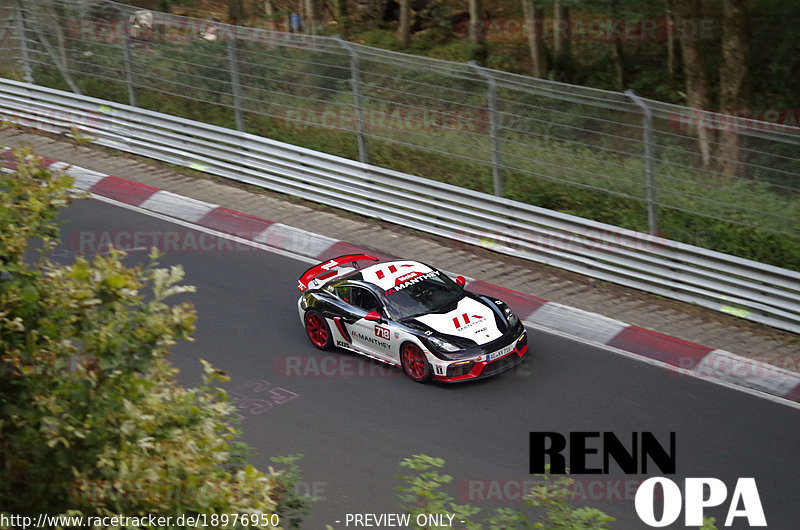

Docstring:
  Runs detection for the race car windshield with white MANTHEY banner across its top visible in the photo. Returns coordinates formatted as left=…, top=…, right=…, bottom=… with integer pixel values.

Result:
left=384, top=270, right=464, bottom=320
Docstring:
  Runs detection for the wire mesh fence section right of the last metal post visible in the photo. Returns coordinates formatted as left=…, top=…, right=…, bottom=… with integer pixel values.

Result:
left=648, top=101, right=800, bottom=260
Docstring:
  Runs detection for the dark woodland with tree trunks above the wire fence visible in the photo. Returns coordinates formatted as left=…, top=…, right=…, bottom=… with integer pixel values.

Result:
left=133, top=0, right=800, bottom=112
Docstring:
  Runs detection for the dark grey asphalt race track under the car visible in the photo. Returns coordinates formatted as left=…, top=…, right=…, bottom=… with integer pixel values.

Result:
left=60, top=200, right=800, bottom=529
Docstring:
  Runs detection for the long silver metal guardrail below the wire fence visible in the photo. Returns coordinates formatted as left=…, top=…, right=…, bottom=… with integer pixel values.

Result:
left=0, top=79, right=800, bottom=333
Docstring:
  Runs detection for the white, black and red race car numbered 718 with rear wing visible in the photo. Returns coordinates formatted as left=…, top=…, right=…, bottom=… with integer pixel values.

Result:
left=297, top=254, right=528, bottom=382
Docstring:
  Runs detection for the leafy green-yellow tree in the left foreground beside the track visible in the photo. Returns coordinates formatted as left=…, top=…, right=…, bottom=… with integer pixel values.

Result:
left=0, top=152, right=304, bottom=527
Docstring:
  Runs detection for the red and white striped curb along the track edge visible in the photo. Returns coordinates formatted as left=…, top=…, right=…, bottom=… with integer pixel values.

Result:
left=6, top=151, right=800, bottom=403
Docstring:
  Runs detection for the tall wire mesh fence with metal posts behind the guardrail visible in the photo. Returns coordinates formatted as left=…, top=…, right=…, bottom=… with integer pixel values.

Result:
left=0, top=0, right=800, bottom=269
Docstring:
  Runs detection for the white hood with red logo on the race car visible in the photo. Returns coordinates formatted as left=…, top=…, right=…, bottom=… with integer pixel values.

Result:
left=414, top=296, right=503, bottom=345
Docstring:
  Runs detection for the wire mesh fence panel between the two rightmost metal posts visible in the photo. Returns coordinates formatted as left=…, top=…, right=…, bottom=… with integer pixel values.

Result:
left=488, top=72, right=645, bottom=209
